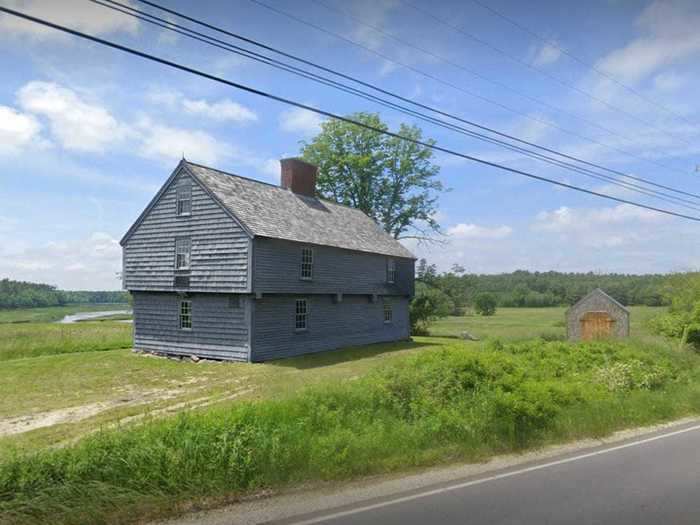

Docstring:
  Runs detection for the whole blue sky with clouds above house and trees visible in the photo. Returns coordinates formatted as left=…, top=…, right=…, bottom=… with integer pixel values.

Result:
left=0, top=0, right=700, bottom=289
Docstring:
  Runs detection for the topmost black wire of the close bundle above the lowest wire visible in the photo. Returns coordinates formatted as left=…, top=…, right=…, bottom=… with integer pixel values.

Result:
left=129, top=0, right=700, bottom=199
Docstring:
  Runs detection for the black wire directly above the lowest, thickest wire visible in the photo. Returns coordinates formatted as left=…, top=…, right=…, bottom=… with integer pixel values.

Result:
left=91, top=0, right=700, bottom=211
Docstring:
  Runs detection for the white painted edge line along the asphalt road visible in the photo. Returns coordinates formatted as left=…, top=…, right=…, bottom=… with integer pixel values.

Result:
left=293, top=425, right=700, bottom=525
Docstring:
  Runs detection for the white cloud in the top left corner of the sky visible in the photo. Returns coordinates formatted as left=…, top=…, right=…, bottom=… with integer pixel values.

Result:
left=0, top=0, right=139, bottom=41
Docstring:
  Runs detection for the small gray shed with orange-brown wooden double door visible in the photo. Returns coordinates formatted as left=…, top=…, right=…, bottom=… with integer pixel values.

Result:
left=566, top=288, right=630, bottom=341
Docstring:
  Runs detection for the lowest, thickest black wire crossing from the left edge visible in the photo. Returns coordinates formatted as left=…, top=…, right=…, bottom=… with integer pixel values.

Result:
left=0, top=6, right=700, bottom=222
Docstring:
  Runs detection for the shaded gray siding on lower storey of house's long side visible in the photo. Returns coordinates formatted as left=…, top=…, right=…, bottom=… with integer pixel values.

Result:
left=251, top=295, right=410, bottom=362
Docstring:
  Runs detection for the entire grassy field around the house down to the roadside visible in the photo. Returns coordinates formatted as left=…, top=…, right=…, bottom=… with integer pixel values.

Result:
left=0, top=302, right=700, bottom=523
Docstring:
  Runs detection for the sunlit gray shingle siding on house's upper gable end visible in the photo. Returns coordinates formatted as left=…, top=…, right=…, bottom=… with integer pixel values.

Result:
left=123, top=172, right=250, bottom=292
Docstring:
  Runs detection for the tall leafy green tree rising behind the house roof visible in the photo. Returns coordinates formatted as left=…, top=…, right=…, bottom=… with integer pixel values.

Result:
left=301, top=113, right=443, bottom=239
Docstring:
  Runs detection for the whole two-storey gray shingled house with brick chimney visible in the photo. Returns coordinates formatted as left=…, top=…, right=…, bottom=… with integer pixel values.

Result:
left=121, top=159, right=415, bottom=361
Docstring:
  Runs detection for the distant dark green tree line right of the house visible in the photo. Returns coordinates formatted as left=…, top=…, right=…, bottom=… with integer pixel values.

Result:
left=416, top=259, right=669, bottom=315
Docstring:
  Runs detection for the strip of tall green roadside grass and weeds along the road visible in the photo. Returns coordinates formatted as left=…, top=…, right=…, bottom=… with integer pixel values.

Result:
left=0, top=340, right=700, bottom=524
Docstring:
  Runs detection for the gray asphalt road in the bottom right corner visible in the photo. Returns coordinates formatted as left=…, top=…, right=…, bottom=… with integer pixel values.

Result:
left=277, top=423, right=700, bottom=525
